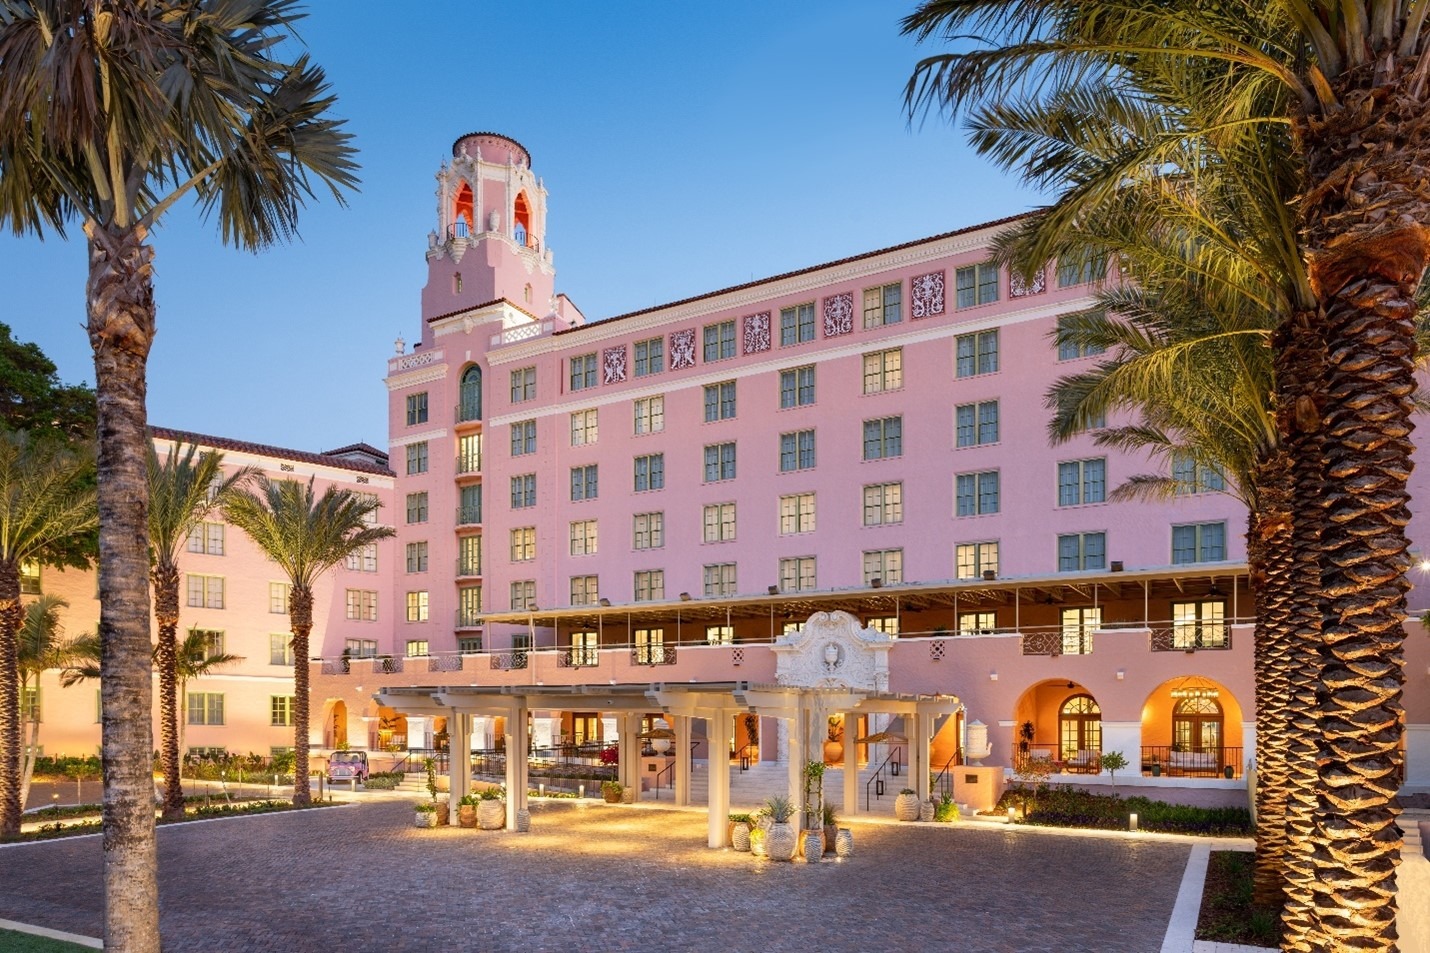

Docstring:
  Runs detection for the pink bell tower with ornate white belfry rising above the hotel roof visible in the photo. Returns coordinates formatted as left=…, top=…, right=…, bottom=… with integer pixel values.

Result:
left=422, top=132, right=559, bottom=319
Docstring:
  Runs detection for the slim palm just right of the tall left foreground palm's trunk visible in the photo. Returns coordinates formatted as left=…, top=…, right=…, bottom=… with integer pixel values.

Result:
left=149, top=442, right=256, bottom=818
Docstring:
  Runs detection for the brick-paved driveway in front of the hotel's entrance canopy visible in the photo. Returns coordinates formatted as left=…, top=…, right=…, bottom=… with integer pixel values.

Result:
left=0, top=800, right=1190, bottom=953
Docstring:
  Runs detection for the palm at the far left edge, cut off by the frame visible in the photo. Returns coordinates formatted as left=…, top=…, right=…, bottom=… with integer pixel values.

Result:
left=0, top=431, right=96, bottom=837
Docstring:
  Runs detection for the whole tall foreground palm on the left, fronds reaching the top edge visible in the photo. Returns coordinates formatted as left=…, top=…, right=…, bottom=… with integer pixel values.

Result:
left=0, top=0, right=356, bottom=952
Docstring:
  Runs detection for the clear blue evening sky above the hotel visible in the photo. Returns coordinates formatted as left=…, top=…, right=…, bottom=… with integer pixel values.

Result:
left=0, top=0, right=1038, bottom=451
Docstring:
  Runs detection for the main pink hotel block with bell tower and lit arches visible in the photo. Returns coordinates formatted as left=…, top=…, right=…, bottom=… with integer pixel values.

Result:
left=19, top=133, right=1430, bottom=824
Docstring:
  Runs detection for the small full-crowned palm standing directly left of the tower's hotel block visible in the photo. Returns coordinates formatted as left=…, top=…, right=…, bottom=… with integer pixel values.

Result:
left=223, top=477, right=393, bottom=806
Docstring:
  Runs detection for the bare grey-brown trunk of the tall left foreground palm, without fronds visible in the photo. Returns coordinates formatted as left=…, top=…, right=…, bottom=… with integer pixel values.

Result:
left=86, top=223, right=160, bottom=953
